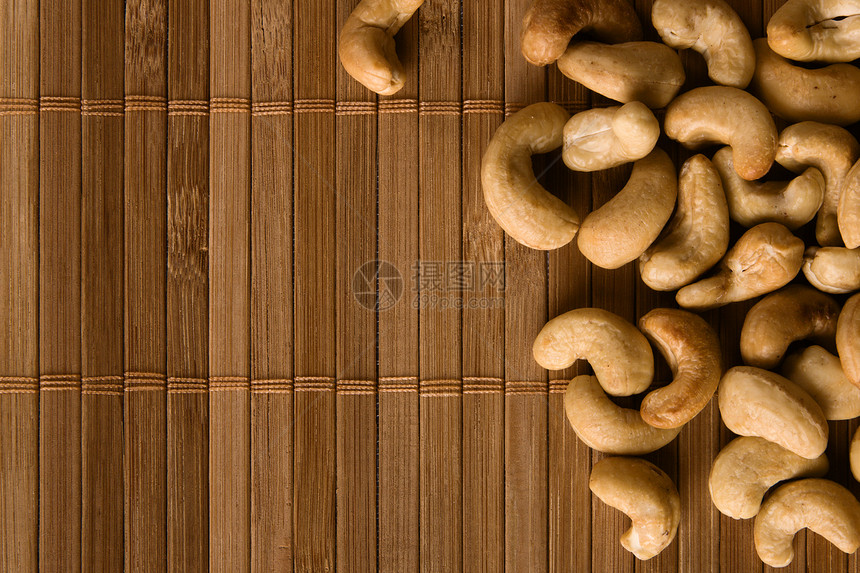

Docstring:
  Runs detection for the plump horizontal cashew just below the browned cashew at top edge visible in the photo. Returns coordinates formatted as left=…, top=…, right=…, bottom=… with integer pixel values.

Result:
left=556, top=42, right=686, bottom=108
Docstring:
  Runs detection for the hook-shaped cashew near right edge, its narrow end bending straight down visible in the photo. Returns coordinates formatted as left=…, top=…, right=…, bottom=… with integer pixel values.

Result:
left=776, top=121, right=860, bottom=247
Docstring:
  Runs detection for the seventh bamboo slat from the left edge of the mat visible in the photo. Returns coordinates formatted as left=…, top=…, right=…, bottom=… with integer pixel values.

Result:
left=251, top=0, right=293, bottom=573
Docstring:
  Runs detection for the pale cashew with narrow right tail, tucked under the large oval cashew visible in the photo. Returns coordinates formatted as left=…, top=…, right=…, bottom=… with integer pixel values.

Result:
left=708, top=436, right=830, bottom=519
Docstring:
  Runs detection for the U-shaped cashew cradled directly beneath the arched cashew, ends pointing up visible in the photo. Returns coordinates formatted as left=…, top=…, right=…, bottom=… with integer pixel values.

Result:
left=713, top=147, right=824, bottom=230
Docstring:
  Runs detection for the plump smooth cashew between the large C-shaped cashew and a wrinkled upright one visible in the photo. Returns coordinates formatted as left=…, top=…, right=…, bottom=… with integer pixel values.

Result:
left=576, top=147, right=678, bottom=269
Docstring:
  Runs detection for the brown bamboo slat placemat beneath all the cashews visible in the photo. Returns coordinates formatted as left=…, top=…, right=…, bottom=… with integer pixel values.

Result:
left=0, top=0, right=860, bottom=573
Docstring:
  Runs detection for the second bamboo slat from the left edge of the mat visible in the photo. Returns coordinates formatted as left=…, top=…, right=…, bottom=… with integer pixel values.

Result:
left=39, top=0, right=82, bottom=573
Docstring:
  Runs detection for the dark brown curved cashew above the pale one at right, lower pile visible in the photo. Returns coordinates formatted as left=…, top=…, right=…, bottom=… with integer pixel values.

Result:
left=741, top=285, right=839, bottom=368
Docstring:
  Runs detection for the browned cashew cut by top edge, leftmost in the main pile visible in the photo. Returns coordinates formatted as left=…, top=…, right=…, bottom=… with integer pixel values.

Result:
left=520, top=0, right=642, bottom=66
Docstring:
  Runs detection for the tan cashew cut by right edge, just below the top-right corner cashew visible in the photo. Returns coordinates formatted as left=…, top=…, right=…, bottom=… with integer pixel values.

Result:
left=752, top=38, right=860, bottom=125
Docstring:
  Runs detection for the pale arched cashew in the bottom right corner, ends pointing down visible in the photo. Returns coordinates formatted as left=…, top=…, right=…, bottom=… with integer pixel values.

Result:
left=754, top=478, right=860, bottom=567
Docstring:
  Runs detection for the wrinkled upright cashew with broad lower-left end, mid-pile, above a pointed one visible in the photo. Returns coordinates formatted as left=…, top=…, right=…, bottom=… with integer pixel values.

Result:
left=639, top=155, right=729, bottom=291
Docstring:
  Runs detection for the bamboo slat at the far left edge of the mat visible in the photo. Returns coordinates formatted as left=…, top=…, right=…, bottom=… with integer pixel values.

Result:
left=0, top=0, right=39, bottom=573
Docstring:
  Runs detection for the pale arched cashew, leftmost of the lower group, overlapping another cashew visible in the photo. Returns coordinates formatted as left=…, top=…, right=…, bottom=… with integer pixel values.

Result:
left=532, top=308, right=654, bottom=396
